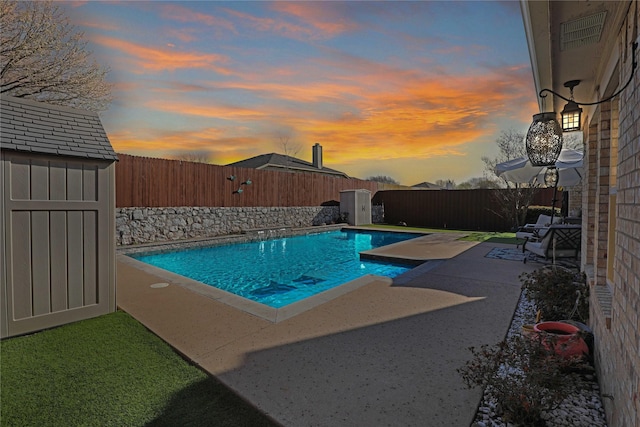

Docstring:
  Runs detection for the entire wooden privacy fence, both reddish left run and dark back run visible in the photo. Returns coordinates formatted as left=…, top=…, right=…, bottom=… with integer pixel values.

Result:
left=115, top=154, right=553, bottom=231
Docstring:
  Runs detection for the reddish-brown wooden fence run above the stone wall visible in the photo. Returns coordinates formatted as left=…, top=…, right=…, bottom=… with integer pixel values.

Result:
left=116, top=154, right=397, bottom=208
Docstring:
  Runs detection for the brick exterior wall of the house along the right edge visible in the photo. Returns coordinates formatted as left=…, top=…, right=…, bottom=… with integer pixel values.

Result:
left=583, top=7, right=640, bottom=427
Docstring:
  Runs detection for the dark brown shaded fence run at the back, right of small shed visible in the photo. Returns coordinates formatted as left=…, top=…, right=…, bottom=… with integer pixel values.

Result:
left=373, top=188, right=553, bottom=231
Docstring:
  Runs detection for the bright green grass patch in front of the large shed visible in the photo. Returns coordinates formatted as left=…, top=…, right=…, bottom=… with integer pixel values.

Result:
left=0, top=312, right=277, bottom=427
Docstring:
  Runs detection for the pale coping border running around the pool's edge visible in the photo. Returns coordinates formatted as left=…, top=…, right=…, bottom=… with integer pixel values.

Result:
left=116, top=229, right=427, bottom=323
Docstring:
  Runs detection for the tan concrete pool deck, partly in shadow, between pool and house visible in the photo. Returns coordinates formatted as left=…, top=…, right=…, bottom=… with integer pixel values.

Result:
left=117, top=233, right=539, bottom=427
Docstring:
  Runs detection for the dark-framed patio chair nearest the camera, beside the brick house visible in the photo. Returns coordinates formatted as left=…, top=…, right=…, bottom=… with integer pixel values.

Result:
left=522, top=224, right=582, bottom=263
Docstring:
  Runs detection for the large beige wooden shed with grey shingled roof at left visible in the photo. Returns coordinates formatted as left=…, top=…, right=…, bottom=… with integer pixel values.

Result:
left=0, top=95, right=117, bottom=338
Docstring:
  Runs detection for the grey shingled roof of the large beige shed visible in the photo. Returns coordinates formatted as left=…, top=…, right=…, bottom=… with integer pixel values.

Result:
left=0, top=95, right=118, bottom=160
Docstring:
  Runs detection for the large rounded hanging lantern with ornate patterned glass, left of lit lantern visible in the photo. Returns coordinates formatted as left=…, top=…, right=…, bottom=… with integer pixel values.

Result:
left=526, top=112, right=562, bottom=166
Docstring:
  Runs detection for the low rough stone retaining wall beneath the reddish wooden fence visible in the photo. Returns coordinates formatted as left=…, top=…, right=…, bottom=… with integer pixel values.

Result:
left=116, top=206, right=384, bottom=246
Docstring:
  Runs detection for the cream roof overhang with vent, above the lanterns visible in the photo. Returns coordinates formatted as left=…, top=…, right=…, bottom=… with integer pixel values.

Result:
left=520, top=0, right=633, bottom=123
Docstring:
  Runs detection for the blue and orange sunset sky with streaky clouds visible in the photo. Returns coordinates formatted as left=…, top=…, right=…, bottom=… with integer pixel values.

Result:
left=64, top=1, right=538, bottom=185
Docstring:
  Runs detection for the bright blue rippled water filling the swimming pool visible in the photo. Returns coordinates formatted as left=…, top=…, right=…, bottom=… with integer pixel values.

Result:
left=131, top=230, right=418, bottom=308
